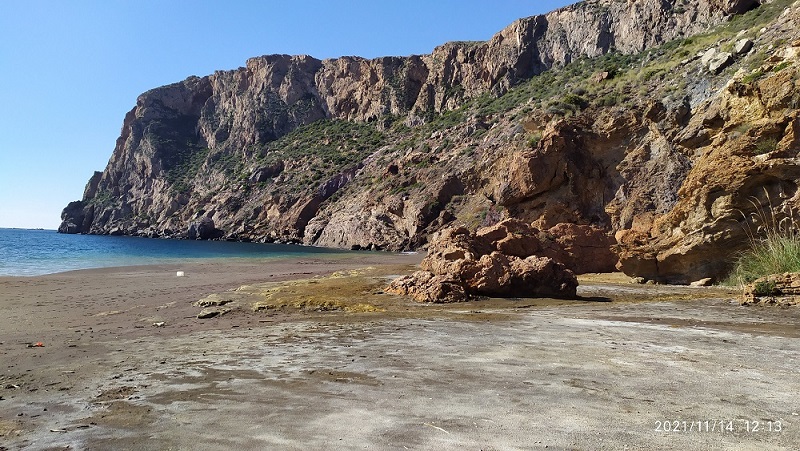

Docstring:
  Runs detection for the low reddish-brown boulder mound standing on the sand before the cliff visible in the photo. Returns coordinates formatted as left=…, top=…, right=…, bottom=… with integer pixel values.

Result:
left=387, top=219, right=578, bottom=303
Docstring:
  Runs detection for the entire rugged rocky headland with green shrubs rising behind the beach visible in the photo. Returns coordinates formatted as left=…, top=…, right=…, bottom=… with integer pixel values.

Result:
left=60, top=0, right=797, bottom=281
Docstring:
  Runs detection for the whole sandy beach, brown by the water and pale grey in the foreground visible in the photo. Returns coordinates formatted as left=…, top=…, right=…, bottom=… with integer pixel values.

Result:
left=0, top=254, right=800, bottom=450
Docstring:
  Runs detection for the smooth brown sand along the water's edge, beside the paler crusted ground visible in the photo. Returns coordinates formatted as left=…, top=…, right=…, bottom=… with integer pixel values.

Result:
left=0, top=253, right=422, bottom=387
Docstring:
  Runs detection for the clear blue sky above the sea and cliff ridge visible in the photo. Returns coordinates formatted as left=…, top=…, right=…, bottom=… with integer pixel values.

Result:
left=0, top=0, right=574, bottom=229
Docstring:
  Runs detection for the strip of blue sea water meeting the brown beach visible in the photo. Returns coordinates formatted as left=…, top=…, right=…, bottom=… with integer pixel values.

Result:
left=0, top=228, right=346, bottom=276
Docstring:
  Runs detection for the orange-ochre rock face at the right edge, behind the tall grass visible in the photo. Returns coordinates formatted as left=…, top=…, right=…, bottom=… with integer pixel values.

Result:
left=616, top=37, right=800, bottom=283
